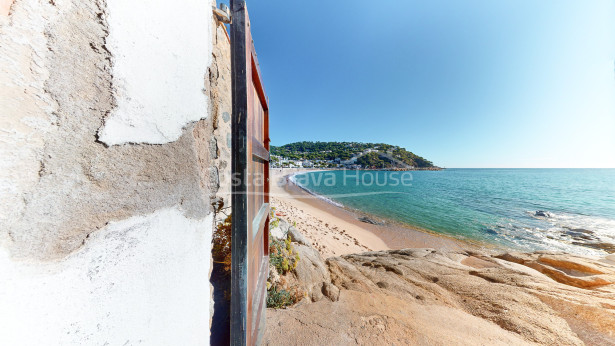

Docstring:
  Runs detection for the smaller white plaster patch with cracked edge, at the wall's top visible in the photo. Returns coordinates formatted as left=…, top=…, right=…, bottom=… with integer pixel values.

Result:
left=99, top=0, right=213, bottom=145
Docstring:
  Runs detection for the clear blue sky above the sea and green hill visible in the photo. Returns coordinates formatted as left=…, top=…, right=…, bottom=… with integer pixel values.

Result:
left=238, top=0, right=615, bottom=167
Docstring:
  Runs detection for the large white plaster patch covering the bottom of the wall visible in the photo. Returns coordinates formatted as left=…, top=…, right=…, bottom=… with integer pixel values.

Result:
left=0, top=207, right=213, bottom=345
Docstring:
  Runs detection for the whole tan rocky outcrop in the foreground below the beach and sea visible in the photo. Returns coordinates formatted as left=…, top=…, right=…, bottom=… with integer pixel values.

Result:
left=265, top=246, right=615, bottom=345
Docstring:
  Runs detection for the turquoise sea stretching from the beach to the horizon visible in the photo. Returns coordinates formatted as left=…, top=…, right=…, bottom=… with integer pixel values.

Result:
left=293, top=169, right=615, bottom=255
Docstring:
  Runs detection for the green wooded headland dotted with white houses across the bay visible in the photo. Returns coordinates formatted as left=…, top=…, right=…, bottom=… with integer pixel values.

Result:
left=271, top=141, right=438, bottom=170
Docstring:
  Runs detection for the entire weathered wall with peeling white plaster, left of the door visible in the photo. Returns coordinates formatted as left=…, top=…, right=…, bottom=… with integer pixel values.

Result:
left=0, top=0, right=231, bottom=344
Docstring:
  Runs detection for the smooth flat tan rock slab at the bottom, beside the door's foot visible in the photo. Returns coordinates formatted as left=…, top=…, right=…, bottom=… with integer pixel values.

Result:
left=263, top=291, right=527, bottom=345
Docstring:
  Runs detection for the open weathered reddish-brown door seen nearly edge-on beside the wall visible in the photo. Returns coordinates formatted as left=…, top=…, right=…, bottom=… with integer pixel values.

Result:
left=231, top=0, right=269, bottom=345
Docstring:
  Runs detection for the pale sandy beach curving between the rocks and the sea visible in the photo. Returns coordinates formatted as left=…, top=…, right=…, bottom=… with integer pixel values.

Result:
left=270, top=169, right=476, bottom=258
